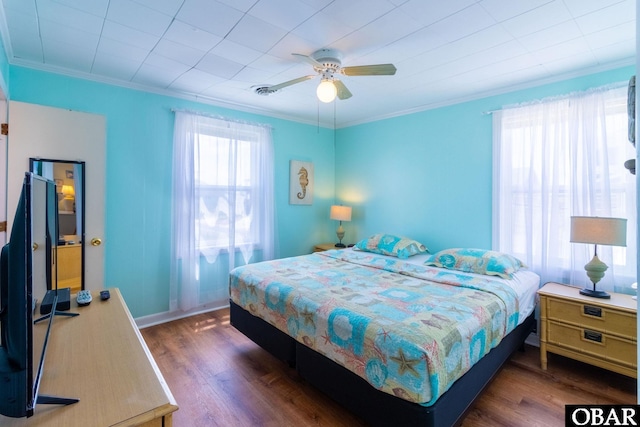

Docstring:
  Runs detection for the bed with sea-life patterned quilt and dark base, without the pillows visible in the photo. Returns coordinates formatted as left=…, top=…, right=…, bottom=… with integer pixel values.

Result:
left=229, top=244, right=539, bottom=426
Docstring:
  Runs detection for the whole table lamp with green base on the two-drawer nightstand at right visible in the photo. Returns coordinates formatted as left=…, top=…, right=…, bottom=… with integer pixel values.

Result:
left=571, top=216, right=627, bottom=298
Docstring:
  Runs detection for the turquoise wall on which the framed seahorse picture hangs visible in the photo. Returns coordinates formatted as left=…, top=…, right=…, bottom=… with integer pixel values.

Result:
left=9, top=67, right=335, bottom=317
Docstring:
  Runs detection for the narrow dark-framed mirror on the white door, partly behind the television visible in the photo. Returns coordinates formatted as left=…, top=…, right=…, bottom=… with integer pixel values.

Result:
left=29, top=158, right=85, bottom=294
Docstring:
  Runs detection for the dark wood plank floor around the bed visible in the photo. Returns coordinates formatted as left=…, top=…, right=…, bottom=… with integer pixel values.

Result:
left=142, top=310, right=637, bottom=427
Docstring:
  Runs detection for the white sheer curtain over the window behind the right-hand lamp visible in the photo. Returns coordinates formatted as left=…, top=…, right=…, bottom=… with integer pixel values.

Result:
left=493, top=87, right=637, bottom=292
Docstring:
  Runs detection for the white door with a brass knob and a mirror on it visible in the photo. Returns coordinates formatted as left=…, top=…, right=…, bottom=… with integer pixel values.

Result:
left=7, top=101, right=106, bottom=299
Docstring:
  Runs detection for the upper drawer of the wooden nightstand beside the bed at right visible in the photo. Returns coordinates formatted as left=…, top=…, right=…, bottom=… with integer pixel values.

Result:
left=548, top=298, right=636, bottom=341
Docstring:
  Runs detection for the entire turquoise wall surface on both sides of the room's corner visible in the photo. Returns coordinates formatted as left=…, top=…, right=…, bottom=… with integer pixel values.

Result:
left=5, top=64, right=635, bottom=317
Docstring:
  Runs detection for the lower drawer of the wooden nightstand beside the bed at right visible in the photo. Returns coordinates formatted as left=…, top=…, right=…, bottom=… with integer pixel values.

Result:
left=547, top=321, right=637, bottom=367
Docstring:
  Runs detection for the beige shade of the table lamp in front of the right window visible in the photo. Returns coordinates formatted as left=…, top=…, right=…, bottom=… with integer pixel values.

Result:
left=571, top=216, right=627, bottom=246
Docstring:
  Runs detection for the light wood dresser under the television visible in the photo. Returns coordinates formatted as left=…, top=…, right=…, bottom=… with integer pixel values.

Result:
left=0, top=288, right=178, bottom=427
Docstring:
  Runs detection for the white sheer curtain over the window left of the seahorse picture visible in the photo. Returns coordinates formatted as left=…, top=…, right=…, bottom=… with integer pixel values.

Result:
left=170, top=111, right=275, bottom=311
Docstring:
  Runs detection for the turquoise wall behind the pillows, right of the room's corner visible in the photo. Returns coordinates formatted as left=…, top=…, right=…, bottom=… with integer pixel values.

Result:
left=336, top=67, right=635, bottom=252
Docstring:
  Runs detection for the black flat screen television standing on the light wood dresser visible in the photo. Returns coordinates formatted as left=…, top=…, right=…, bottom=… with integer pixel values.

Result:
left=0, top=172, right=78, bottom=418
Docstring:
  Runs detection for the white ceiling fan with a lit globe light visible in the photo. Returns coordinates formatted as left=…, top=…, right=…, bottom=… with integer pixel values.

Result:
left=255, top=49, right=396, bottom=102
